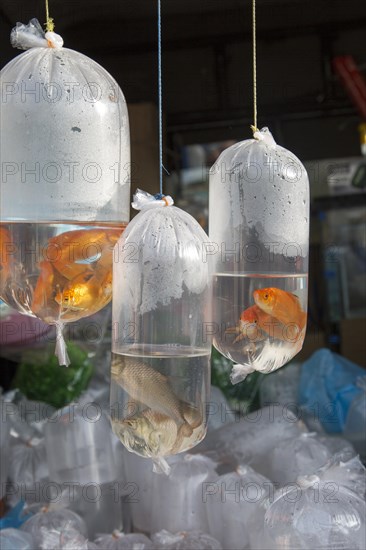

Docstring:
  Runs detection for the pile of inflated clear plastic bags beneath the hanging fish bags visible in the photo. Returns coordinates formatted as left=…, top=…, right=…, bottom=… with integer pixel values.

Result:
left=0, top=370, right=366, bottom=550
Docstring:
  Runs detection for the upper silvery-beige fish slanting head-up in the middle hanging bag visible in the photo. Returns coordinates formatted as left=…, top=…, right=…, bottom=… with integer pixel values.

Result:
left=111, top=357, right=202, bottom=436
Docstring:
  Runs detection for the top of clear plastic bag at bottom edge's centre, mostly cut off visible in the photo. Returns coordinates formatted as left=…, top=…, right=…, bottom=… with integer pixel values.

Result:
left=151, top=529, right=222, bottom=550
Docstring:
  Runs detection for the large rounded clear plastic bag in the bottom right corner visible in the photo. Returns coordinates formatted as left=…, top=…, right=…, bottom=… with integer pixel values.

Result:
left=264, top=475, right=366, bottom=550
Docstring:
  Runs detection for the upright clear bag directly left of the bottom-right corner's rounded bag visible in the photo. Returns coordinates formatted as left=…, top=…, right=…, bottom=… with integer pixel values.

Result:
left=204, top=466, right=274, bottom=550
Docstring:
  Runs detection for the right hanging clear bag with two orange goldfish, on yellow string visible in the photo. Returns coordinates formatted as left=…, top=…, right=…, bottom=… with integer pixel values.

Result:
left=209, top=128, right=309, bottom=384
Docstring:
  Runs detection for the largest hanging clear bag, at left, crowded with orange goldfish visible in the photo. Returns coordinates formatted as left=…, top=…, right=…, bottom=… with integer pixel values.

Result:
left=0, top=19, right=130, bottom=365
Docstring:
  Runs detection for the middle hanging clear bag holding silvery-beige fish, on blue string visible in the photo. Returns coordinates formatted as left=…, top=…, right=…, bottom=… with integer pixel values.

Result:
left=111, top=190, right=211, bottom=471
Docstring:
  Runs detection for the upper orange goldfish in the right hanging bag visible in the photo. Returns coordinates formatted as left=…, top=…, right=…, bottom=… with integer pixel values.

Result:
left=253, top=287, right=307, bottom=330
